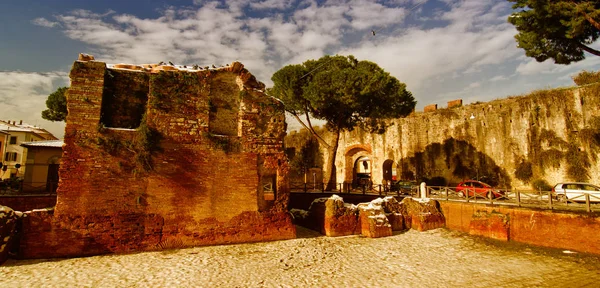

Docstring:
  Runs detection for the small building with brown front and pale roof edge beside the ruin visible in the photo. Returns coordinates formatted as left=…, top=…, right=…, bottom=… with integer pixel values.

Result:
left=21, top=140, right=63, bottom=193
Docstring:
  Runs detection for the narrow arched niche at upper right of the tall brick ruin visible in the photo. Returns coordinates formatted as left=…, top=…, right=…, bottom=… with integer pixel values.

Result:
left=208, top=74, right=241, bottom=136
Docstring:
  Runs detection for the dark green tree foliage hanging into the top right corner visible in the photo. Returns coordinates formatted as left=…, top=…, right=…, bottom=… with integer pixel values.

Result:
left=508, top=0, right=600, bottom=64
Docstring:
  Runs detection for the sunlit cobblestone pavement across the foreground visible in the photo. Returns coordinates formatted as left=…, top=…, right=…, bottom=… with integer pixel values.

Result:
left=0, top=227, right=600, bottom=287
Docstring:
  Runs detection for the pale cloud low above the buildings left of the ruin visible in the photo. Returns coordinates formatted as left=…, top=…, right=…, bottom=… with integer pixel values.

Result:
left=0, top=71, right=68, bottom=137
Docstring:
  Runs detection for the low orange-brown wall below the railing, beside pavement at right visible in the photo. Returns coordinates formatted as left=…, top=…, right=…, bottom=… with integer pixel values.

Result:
left=439, top=201, right=600, bottom=254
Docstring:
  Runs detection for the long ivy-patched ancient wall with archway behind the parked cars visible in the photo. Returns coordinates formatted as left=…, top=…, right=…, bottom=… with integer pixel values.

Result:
left=321, top=84, right=600, bottom=189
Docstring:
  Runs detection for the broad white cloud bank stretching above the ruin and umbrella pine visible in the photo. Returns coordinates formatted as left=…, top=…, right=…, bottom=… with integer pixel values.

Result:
left=17, top=0, right=600, bottom=130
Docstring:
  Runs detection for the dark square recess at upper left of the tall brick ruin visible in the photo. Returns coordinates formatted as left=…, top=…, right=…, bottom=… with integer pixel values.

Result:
left=100, top=69, right=149, bottom=129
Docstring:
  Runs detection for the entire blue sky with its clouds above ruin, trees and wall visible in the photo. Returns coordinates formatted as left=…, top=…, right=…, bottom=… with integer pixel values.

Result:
left=0, top=0, right=600, bottom=137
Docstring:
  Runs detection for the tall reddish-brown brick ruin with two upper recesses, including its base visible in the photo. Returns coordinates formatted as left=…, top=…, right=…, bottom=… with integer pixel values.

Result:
left=19, top=61, right=295, bottom=258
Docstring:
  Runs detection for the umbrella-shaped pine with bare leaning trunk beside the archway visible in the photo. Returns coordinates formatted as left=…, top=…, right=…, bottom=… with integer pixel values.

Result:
left=269, top=55, right=416, bottom=189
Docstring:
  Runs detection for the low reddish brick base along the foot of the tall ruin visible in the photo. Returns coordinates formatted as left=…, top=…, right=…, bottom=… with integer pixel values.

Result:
left=17, top=209, right=296, bottom=259
